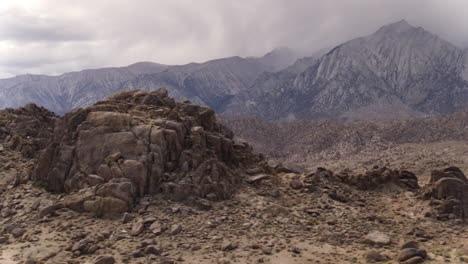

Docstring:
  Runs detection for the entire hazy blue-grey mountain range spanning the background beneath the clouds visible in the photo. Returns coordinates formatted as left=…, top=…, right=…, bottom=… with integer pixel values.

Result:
left=0, top=20, right=468, bottom=120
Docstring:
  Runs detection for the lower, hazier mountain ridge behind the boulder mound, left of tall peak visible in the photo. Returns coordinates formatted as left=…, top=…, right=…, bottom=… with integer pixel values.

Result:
left=0, top=48, right=296, bottom=114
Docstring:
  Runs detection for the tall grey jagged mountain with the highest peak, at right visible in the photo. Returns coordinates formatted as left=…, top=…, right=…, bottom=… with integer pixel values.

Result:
left=226, top=21, right=468, bottom=120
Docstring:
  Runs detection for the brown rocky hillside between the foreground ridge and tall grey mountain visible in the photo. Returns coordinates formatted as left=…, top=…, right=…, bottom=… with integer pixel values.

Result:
left=221, top=111, right=468, bottom=176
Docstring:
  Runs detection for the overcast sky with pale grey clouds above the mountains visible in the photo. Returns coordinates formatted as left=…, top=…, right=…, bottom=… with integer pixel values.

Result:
left=0, top=0, right=468, bottom=78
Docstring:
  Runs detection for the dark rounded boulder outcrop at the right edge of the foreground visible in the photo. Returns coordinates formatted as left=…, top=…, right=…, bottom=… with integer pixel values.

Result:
left=422, top=167, right=468, bottom=220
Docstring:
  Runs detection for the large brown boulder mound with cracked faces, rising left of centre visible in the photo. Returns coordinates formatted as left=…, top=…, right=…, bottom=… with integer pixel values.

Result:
left=33, top=89, right=263, bottom=216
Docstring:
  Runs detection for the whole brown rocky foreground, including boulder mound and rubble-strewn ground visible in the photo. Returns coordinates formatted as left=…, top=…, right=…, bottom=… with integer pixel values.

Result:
left=0, top=89, right=468, bottom=264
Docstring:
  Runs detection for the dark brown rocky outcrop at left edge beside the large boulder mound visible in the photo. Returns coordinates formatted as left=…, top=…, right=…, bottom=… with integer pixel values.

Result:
left=0, top=104, right=57, bottom=158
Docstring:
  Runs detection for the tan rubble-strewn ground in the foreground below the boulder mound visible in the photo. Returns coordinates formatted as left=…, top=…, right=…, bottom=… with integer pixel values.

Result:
left=0, top=156, right=468, bottom=264
